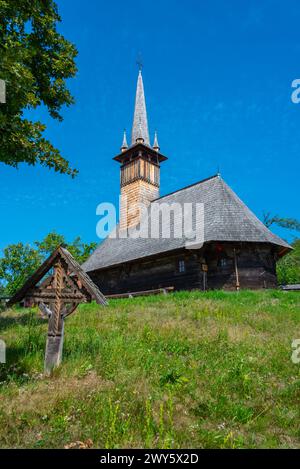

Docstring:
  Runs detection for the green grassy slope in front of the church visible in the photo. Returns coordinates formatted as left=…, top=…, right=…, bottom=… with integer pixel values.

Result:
left=0, top=291, right=300, bottom=448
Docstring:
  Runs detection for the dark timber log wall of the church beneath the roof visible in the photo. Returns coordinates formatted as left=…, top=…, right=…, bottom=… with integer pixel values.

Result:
left=90, top=243, right=277, bottom=295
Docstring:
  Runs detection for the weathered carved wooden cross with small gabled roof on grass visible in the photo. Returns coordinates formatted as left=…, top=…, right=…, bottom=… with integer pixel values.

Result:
left=8, top=246, right=107, bottom=374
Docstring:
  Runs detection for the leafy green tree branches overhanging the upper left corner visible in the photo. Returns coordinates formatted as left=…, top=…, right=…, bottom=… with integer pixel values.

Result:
left=0, top=0, right=77, bottom=177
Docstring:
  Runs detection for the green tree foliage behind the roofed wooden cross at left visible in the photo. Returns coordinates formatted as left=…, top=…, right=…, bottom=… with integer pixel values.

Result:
left=0, top=232, right=96, bottom=296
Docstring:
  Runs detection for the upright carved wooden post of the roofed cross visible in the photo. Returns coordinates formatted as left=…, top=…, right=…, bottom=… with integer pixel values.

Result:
left=45, top=262, right=64, bottom=375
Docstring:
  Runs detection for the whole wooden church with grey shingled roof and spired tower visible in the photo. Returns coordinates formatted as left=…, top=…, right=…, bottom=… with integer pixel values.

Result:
left=83, top=71, right=291, bottom=295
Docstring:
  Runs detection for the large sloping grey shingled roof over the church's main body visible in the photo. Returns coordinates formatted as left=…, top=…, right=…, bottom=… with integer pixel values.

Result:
left=82, top=175, right=291, bottom=272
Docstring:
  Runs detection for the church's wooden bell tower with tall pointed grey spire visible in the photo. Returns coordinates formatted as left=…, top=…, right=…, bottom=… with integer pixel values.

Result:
left=114, top=70, right=167, bottom=230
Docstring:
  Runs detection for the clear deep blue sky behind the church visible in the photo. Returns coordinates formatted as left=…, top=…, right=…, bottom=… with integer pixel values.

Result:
left=0, top=0, right=300, bottom=248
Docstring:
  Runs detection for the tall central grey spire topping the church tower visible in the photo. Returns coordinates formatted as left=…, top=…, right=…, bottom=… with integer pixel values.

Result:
left=131, top=70, right=150, bottom=145
